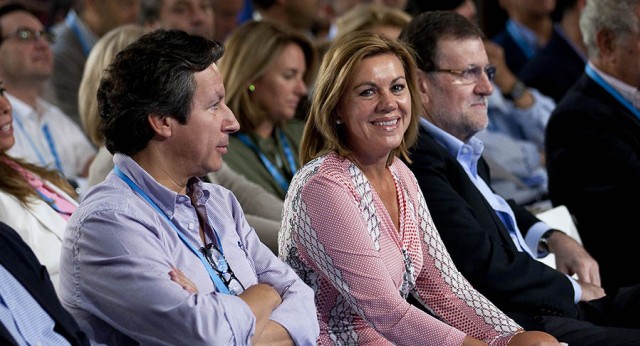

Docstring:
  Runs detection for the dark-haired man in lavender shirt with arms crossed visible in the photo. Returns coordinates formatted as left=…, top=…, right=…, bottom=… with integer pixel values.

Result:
left=60, top=30, right=319, bottom=345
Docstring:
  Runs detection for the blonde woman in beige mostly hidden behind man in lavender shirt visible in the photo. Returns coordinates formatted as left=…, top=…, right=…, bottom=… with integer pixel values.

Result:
left=78, top=24, right=282, bottom=254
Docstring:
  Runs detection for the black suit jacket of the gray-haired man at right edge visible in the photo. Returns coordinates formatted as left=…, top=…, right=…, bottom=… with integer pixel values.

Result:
left=545, top=74, right=640, bottom=293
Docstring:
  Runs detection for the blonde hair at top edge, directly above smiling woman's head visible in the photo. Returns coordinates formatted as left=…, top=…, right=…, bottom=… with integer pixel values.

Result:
left=336, top=3, right=411, bottom=39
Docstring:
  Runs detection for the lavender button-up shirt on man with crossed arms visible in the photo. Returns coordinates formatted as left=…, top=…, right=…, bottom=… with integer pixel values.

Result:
left=60, top=154, right=319, bottom=345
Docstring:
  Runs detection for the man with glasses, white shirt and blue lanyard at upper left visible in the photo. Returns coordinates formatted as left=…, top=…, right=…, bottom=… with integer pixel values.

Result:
left=0, top=5, right=96, bottom=192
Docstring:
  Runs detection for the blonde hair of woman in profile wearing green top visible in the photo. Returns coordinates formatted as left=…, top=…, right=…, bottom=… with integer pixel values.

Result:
left=218, top=20, right=317, bottom=133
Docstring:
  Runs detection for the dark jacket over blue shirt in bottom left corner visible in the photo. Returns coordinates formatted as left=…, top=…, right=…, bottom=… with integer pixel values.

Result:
left=0, top=222, right=89, bottom=345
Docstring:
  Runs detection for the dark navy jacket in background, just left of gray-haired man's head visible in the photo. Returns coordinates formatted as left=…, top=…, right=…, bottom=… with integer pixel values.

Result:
left=519, top=26, right=585, bottom=103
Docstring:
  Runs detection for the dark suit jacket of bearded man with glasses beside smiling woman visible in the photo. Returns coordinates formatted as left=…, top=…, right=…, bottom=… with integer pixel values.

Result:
left=409, top=127, right=577, bottom=327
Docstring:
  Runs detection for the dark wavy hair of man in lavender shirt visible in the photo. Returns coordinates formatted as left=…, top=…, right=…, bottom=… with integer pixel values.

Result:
left=98, top=29, right=224, bottom=155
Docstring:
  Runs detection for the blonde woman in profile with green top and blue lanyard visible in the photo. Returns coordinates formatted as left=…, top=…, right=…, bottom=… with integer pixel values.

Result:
left=220, top=20, right=316, bottom=200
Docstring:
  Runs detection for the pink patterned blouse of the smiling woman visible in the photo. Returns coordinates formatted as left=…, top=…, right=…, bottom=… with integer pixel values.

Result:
left=279, top=153, right=520, bottom=345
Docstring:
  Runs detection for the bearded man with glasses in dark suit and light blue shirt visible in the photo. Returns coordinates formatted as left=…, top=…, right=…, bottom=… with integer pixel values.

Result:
left=400, top=11, right=640, bottom=345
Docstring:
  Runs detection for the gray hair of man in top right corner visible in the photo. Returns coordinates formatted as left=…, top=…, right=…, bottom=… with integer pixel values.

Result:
left=580, top=0, right=640, bottom=57
